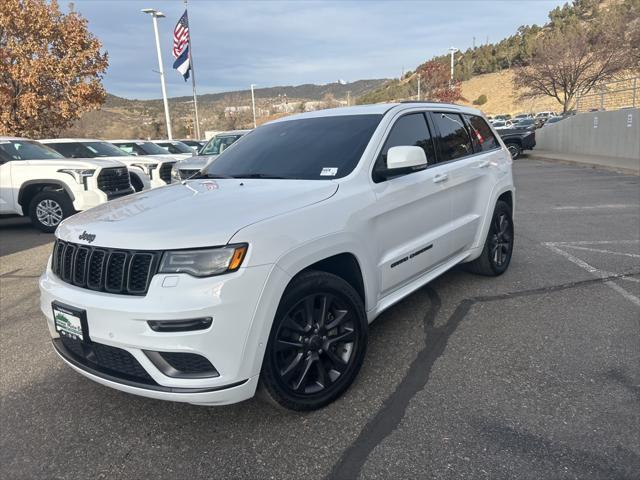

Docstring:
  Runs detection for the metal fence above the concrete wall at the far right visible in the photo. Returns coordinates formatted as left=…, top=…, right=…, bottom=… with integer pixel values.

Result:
left=576, top=77, right=640, bottom=113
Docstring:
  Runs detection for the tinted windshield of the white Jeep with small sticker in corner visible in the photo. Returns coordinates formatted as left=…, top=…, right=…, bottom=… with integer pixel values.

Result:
left=203, top=115, right=382, bottom=180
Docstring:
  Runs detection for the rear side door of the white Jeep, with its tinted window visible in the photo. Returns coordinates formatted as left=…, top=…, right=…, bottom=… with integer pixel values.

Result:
left=432, top=112, right=503, bottom=251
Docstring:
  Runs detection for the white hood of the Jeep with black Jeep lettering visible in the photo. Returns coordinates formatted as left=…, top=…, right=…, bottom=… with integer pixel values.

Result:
left=56, top=179, right=338, bottom=250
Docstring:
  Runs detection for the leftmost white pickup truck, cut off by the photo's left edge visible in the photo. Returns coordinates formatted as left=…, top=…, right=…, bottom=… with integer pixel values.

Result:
left=0, top=137, right=133, bottom=232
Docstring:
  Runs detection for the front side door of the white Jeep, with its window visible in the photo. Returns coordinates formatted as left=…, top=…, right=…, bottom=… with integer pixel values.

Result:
left=371, top=112, right=452, bottom=296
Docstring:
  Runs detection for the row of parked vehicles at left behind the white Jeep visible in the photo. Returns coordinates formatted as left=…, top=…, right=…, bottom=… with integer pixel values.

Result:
left=0, top=130, right=247, bottom=232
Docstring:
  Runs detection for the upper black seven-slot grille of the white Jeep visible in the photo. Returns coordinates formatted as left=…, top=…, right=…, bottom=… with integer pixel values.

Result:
left=51, top=240, right=161, bottom=295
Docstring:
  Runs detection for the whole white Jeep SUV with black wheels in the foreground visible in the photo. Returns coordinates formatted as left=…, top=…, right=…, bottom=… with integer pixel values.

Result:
left=40, top=103, right=514, bottom=410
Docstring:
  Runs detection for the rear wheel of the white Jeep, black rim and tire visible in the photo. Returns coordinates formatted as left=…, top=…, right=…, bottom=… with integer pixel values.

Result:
left=466, top=200, right=514, bottom=277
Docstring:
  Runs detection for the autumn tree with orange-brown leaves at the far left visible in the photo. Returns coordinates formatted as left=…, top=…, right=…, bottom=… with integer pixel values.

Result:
left=0, top=0, right=108, bottom=138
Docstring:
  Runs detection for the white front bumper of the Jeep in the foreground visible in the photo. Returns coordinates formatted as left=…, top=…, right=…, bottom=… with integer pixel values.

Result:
left=40, top=265, right=272, bottom=405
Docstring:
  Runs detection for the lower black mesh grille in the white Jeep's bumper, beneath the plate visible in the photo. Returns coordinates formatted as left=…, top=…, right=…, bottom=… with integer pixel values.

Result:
left=60, top=335, right=156, bottom=385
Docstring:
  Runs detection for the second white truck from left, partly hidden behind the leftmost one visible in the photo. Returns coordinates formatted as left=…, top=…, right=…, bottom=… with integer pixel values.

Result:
left=40, top=138, right=166, bottom=192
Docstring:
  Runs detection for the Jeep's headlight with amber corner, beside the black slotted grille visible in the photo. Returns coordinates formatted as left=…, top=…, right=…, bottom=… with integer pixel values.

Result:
left=159, top=244, right=248, bottom=277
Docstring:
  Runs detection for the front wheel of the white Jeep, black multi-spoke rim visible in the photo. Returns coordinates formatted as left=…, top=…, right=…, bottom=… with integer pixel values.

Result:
left=260, top=271, right=368, bottom=411
